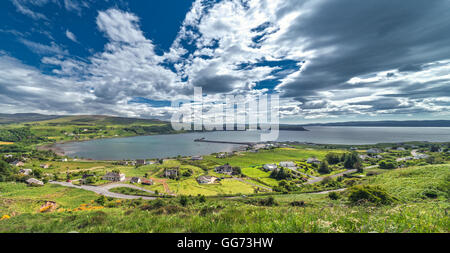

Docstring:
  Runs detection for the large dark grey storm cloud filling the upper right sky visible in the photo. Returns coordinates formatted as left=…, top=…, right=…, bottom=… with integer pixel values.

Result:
left=280, top=0, right=450, bottom=99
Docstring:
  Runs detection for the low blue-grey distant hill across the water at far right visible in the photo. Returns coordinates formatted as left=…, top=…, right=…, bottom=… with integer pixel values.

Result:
left=303, top=120, right=450, bottom=127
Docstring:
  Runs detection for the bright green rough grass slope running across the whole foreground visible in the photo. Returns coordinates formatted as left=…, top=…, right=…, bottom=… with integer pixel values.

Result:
left=0, top=164, right=450, bottom=233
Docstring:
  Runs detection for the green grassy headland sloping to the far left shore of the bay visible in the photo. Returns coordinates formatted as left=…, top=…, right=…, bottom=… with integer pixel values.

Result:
left=0, top=115, right=179, bottom=143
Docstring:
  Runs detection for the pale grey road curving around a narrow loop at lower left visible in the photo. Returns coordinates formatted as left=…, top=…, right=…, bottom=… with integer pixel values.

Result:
left=49, top=181, right=156, bottom=200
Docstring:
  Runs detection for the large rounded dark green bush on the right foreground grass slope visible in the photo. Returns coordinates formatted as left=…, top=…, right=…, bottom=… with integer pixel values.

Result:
left=348, top=185, right=396, bottom=205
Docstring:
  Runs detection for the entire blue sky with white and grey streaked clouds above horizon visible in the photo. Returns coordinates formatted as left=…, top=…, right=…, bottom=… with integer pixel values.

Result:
left=0, top=0, right=450, bottom=123
